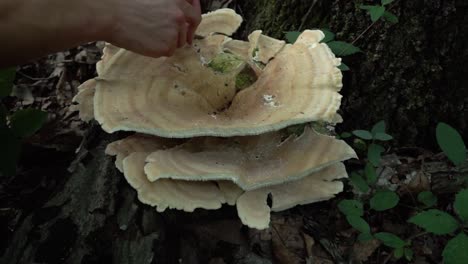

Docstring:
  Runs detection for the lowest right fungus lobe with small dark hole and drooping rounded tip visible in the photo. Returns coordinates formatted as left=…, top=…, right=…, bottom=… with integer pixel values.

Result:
left=236, top=162, right=347, bottom=229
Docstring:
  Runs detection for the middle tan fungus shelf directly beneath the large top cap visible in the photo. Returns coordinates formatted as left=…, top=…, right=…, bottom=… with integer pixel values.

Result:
left=145, top=128, right=356, bottom=190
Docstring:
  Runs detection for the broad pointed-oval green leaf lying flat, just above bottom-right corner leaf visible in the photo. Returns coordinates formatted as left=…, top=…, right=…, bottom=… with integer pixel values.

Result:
left=408, top=209, right=458, bottom=235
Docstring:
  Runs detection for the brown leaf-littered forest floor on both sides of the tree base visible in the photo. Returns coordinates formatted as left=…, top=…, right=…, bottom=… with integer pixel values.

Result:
left=0, top=43, right=466, bottom=264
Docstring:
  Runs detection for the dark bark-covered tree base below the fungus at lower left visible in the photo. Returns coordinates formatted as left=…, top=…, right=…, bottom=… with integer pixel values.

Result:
left=0, top=125, right=271, bottom=264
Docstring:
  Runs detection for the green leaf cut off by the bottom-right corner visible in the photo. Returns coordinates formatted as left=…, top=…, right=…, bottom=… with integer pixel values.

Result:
left=442, top=233, right=468, bottom=264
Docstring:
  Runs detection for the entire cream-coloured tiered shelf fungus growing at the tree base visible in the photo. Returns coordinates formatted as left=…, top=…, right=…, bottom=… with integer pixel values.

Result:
left=74, top=9, right=356, bottom=229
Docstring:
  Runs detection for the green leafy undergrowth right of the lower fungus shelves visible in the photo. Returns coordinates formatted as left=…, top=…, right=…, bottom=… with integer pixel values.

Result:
left=338, top=121, right=468, bottom=264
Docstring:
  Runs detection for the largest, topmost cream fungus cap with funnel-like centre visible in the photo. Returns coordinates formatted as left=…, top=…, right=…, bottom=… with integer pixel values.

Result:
left=94, top=27, right=342, bottom=138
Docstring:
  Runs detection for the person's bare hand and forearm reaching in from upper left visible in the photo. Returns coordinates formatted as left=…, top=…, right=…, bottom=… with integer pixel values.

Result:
left=0, top=0, right=201, bottom=68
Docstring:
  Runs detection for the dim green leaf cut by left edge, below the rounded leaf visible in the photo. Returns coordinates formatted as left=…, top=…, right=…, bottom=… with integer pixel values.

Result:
left=0, top=126, right=21, bottom=176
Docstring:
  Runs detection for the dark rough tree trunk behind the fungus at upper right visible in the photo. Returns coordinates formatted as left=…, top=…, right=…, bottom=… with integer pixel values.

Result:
left=238, top=0, right=468, bottom=147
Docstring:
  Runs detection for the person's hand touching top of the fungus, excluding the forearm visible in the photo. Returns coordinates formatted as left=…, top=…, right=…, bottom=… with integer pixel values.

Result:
left=104, top=0, right=201, bottom=57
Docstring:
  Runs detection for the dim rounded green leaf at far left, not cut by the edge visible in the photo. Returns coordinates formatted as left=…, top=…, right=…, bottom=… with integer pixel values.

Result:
left=10, top=108, right=47, bottom=138
